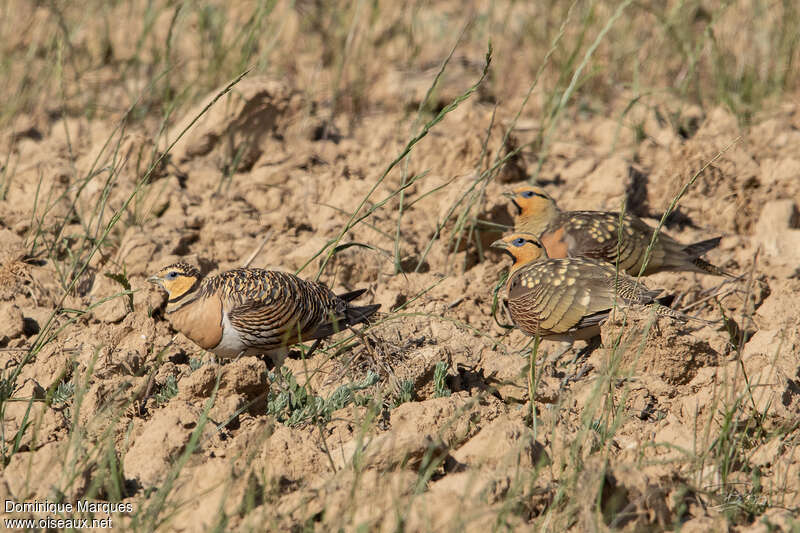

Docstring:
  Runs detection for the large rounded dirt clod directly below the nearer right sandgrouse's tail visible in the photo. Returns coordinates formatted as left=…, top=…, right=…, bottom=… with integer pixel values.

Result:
left=601, top=309, right=719, bottom=385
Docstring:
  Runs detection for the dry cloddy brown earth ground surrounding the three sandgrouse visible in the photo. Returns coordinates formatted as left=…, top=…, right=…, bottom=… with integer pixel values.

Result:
left=0, top=2, right=800, bottom=531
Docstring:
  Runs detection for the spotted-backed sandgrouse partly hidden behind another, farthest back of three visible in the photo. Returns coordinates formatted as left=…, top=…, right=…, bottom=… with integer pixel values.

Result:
left=504, top=185, right=730, bottom=277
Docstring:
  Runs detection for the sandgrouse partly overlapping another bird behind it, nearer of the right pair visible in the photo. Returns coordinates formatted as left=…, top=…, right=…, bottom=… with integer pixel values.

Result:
left=492, top=233, right=681, bottom=342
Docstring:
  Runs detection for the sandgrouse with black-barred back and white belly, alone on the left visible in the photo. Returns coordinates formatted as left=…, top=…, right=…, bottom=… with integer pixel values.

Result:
left=148, top=263, right=380, bottom=366
